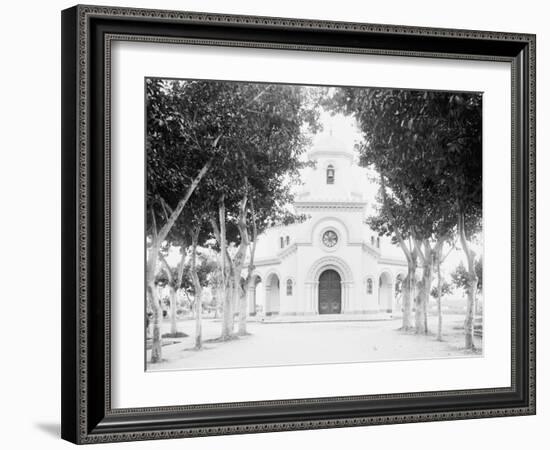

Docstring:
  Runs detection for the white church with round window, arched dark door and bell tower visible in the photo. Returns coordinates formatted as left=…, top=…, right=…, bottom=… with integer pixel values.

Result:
left=248, top=134, right=407, bottom=319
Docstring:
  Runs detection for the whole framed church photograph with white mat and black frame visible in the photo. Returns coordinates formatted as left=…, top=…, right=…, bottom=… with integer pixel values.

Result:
left=62, top=6, right=535, bottom=444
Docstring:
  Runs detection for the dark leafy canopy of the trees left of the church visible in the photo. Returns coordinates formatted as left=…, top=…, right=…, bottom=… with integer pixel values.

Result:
left=147, top=79, right=318, bottom=227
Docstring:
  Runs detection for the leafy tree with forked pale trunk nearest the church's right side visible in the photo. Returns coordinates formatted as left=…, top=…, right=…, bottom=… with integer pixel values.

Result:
left=333, top=88, right=462, bottom=333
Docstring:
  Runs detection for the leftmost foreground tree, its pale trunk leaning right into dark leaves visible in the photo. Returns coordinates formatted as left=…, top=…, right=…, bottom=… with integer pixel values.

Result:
left=146, top=79, right=233, bottom=362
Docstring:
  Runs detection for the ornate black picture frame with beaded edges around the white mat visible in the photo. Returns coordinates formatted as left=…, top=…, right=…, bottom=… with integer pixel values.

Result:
left=62, top=6, right=535, bottom=444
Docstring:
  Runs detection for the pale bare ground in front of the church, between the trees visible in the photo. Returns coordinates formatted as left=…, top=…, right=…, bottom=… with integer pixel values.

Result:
left=147, top=315, right=483, bottom=370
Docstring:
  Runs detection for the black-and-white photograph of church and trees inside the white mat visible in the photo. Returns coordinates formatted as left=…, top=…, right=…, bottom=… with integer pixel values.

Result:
left=146, top=77, right=484, bottom=371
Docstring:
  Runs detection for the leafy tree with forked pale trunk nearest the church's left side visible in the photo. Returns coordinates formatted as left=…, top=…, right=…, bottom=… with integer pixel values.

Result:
left=197, top=83, right=317, bottom=340
